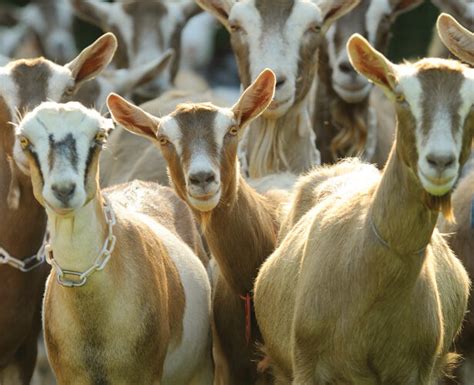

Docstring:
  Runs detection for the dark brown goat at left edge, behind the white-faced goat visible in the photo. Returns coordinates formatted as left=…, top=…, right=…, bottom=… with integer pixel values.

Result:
left=0, top=34, right=117, bottom=385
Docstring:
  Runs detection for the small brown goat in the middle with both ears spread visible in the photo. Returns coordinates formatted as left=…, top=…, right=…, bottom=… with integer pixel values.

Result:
left=108, top=70, right=284, bottom=385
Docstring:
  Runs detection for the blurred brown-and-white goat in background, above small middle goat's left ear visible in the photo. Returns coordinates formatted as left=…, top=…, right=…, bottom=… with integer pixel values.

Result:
left=71, top=0, right=199, bottom=102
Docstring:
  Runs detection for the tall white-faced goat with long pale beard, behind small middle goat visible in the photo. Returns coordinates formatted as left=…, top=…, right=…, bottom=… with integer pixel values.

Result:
left=196, top=0, right=359, bottom=178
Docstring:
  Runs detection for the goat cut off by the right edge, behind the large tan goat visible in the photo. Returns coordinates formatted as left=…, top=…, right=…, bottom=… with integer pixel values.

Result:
left=437, top=14, right=474, bottom=385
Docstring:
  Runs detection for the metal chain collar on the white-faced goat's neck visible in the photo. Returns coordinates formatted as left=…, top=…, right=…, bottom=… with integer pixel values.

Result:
left=46, top=199, right=117, bottom=287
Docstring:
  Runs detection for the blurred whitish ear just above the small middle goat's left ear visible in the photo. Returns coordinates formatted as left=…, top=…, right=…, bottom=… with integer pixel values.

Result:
left=111, top=49, right=174, bottom=94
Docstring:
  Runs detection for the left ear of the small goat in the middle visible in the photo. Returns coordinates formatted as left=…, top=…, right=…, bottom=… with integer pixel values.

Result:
left=107, top=93, right=160, bottom=139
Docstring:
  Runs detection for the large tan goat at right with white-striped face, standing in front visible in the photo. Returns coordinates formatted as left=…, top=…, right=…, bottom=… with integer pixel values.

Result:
left=254, top=35, right=474, bottom=385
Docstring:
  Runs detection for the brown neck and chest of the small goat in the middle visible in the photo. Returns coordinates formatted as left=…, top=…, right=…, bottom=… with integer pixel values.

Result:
left=196, top=177, right=278, bottom=295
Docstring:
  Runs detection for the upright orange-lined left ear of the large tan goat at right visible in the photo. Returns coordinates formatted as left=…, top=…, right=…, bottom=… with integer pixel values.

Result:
left=347, top=34, right=396, bottom=95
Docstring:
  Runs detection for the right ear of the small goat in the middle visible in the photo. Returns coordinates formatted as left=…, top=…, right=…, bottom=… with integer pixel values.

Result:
left=232, top=69, right=276, bottom=128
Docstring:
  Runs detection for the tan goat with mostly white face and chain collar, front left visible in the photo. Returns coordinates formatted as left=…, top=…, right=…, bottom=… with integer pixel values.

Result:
left=17, top=102, right=213, bottom=385
